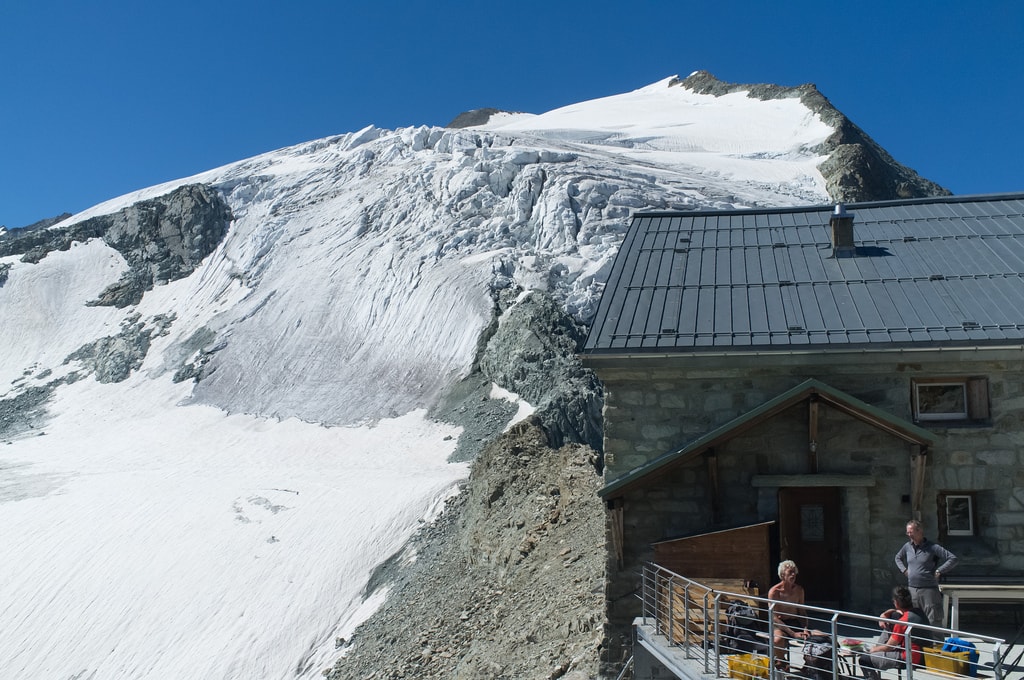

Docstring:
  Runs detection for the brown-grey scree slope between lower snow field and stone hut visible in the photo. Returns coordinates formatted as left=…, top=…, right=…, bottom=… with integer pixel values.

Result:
left=325, top=420, right=604, bottom=680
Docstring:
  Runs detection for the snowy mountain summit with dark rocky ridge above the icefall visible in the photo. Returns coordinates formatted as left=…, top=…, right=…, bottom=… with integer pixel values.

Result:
left=450, top=71, right=949, bottom=203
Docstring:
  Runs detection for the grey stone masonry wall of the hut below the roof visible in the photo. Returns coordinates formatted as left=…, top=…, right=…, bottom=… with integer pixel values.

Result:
left=589, top=350, right=1024, bottom=651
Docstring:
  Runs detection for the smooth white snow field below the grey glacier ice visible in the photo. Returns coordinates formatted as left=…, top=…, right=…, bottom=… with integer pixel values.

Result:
left=0, top=380, right=465, bottom=679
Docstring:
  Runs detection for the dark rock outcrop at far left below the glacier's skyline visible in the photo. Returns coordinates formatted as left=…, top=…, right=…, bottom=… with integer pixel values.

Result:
left=0, top=184, right=231, bottom=307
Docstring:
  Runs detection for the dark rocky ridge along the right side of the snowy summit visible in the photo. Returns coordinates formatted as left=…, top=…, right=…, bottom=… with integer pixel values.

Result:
left=672, top=71, right=951, bottom=203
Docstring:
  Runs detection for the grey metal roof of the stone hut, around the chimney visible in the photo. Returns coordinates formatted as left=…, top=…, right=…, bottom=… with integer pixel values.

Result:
left=584, top=189, right=1024, bottom=355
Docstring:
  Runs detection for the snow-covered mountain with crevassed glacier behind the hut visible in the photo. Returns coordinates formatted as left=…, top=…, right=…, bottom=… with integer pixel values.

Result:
left=0, top=73, right=942, bottom=680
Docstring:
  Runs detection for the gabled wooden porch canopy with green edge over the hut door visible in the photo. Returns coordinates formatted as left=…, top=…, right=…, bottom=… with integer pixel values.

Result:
left=598, top=378, right=935, bottom=501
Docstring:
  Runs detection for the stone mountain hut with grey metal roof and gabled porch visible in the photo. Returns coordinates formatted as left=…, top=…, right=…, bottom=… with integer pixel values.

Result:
left=583, top=195, right=1024, bottom=655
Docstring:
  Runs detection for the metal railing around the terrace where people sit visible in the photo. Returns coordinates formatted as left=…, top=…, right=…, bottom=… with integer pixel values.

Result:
left=638, top=563, right=1009, bottom=680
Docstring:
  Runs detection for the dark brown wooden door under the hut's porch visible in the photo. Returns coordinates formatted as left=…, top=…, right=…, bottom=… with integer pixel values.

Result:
left=778, top=486, right=844, bottom=606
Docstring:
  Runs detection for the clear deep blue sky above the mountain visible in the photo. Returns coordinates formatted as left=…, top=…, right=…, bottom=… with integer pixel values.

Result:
left=0, top=0, right=1024, bottom=227
